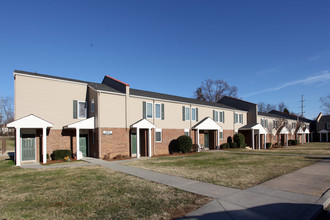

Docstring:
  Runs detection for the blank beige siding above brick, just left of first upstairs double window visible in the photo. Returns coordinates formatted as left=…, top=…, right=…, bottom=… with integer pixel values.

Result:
left=98, top=92, right=126, bottom=128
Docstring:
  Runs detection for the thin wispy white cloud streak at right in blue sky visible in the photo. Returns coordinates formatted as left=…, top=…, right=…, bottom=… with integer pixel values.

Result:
left=243, top=70, right=330, bottom=97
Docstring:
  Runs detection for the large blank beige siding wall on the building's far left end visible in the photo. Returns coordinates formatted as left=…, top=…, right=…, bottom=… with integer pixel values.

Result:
left=15, top=74, right=87, bottom=129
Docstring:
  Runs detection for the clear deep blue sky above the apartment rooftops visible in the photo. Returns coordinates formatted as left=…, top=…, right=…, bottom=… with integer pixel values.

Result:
left=0, top=0, right=330, bottom=118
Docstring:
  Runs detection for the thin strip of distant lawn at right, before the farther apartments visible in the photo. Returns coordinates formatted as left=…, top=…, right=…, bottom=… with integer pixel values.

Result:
left=228, top=142, right=330, bottom=156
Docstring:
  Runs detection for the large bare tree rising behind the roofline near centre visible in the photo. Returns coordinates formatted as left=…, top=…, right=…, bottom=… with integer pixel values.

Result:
left=194, top=79, right=237, bottom=102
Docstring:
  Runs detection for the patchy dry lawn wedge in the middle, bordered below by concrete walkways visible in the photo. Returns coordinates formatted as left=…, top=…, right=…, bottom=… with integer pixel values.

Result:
left=126, top=152, right=318, bottom=189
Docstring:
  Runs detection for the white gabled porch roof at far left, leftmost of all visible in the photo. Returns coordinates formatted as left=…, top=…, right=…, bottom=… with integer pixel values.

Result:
left=7, top=114, right=54, bottom=128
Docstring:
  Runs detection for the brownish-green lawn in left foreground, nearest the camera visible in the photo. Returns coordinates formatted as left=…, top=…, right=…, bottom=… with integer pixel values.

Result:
left=0, top=161, right=211, bottom=219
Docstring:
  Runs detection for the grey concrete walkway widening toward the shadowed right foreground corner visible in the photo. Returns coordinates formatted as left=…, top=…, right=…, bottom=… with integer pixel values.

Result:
left=84, top=158, right=330, bottom=219
